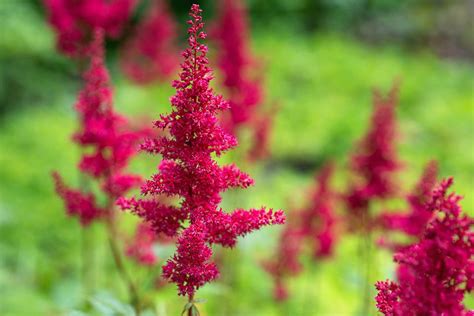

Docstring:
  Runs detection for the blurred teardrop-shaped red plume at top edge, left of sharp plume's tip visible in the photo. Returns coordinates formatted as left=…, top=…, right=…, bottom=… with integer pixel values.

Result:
left=121, top=0, right=178, bottom=83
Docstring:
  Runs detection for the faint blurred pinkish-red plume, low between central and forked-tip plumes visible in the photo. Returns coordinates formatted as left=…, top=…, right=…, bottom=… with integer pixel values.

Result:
left=264, top=163, right=335, bottom=301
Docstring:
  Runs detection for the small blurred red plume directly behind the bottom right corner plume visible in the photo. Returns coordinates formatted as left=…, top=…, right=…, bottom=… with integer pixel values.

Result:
left=381, top=161, right=438, bottom=244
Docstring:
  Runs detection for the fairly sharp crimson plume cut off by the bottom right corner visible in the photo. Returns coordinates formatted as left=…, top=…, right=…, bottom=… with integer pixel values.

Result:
left=376, top=178, right=474, bottom=316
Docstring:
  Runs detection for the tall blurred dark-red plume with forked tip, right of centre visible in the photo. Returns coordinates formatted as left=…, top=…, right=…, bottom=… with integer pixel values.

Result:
left=345, top=85, right=400, bottom=231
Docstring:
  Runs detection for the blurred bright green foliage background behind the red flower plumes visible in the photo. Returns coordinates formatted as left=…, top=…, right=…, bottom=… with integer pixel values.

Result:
left=0, top=0, right=474, bottom=316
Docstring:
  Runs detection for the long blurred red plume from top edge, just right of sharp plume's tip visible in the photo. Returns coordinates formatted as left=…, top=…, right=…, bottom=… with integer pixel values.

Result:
left=213, top=0, right=275, bottom=160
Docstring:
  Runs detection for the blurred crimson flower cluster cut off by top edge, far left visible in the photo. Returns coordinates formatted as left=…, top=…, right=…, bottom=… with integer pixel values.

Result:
left=44, top=0, right=136, bottom=57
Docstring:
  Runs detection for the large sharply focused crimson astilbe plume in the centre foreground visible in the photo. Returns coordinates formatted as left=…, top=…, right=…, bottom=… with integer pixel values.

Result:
left=118, top=4, right=284, bottom=300
